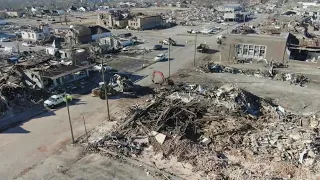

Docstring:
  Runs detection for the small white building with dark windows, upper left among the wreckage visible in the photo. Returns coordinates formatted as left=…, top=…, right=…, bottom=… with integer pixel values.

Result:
left=21, top=25, right=50, bottom=42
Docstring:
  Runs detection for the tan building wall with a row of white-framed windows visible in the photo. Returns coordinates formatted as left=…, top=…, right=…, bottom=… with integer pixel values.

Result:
left=220, top=34, right=289, bottom=62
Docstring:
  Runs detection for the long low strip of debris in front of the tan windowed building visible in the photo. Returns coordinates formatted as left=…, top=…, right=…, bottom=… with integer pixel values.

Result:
left=200, top=63, right=309, bottom=86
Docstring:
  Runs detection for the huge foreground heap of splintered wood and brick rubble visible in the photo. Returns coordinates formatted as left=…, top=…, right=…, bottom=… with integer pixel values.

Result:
left=88, top=84, right=320, bottom=179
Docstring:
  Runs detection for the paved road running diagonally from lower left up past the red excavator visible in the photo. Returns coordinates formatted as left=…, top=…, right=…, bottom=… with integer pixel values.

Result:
left=0, top=14, right=264, bottom=179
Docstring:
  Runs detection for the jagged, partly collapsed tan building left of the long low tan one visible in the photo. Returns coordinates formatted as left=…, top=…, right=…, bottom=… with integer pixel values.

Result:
left=97, top=13, right=128, bottom=28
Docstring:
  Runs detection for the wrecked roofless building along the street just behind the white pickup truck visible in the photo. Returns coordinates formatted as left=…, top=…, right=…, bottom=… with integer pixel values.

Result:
left=18, top=49, right=95, bottom=88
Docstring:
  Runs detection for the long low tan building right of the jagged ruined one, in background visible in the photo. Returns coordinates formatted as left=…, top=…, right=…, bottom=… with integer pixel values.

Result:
left=128, top=15, right=162, bottom=30
